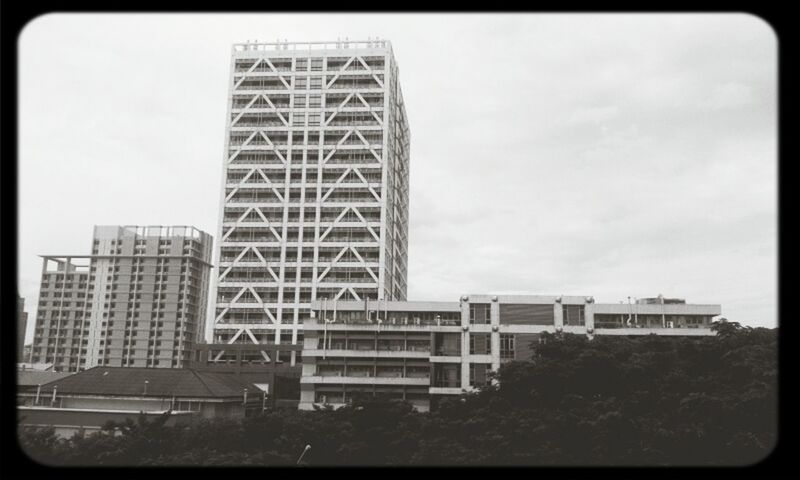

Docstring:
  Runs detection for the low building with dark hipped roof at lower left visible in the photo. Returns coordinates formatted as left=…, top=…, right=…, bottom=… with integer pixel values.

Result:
left=17, top=367, right=266, bottom=437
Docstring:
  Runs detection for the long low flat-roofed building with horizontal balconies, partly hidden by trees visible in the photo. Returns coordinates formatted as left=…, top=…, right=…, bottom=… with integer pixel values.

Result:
left=299, top=295, right=721, bottom=411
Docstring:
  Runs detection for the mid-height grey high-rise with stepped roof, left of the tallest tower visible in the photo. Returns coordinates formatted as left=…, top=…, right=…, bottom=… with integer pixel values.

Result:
left=30, top=226, right=212, bottom=372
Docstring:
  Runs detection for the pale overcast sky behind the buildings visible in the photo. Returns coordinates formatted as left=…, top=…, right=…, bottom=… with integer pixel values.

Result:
left=19, top=14, right=777, bottom=341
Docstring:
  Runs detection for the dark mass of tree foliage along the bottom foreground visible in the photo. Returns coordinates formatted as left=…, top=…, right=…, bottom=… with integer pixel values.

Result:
left=20, top=328, right=777, bottom=466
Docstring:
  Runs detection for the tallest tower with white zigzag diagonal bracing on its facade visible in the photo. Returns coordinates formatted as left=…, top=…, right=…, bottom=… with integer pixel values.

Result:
left=212, top=40, right=409, bottom=365
